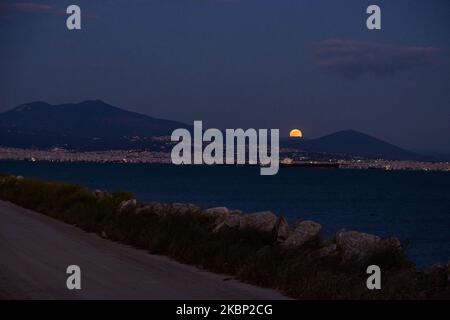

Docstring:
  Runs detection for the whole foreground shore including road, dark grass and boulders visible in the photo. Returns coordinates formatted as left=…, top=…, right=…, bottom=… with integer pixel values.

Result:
left=0, top=175, right=450, bottom=299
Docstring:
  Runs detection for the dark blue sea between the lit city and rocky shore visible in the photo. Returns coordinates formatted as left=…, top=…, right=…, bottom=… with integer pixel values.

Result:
left=0, top=162, right=450, bottom=267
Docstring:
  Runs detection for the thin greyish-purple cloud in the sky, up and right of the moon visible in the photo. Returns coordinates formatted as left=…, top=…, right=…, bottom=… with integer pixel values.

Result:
left=314, top=39, right=444, bottom=77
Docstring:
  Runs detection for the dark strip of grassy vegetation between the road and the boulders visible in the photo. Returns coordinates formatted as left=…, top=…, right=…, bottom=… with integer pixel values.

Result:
left=0, top=174, right=450, bottom=299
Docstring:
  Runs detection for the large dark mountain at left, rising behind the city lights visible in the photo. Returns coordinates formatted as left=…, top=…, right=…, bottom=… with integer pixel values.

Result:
left=0, top=100, right=190, bottom=149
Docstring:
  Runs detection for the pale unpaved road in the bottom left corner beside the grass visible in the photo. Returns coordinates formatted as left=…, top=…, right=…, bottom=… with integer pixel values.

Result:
left=0, top=201, right=285, bottom=299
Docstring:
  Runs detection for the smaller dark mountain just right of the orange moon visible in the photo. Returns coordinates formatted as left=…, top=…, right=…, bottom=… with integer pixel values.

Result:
left=281, top=130, right=429, bottom=160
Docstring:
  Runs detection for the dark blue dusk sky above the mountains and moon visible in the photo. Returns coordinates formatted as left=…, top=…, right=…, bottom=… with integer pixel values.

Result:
left=0, top=0, right=450, bottom=153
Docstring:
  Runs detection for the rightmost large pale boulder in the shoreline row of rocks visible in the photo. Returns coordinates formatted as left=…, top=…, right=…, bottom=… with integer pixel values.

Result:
left=336, top=231, right=381, bottom=262
